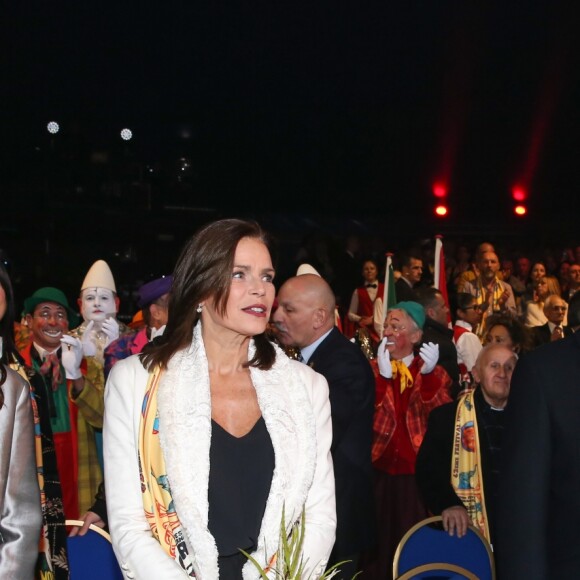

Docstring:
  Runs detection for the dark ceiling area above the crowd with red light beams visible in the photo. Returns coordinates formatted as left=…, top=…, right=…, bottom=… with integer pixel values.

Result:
left=0, top=0, right=580, bottom=308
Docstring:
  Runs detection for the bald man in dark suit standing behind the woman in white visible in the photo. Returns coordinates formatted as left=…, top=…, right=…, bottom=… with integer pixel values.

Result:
left=272, top=274, right=375, bottom=580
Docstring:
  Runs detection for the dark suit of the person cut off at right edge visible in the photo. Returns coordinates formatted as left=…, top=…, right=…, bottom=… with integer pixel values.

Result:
left=495, top=332, right=580, bottom=580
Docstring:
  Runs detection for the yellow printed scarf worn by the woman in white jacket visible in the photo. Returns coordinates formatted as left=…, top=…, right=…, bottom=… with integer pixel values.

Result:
left=139, top=368, right=195, bottom=578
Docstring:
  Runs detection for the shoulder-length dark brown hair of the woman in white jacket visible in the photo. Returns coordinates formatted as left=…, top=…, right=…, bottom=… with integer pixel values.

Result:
left=140, top=219, right=276, bottom=370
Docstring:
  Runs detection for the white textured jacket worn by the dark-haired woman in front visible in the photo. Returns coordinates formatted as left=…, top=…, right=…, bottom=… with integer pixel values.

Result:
left=103, top=324, right=336, bottom=580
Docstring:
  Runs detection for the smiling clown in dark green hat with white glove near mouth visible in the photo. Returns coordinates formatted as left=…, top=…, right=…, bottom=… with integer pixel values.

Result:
left=20, top=286, right=104, bottom=532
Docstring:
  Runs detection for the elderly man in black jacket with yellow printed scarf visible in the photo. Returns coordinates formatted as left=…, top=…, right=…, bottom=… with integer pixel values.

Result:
left=415, top=344, right=517, bottom=542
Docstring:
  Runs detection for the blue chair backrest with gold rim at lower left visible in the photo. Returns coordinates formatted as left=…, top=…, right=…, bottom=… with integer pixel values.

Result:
left=66, top=520, right=123, bottom=580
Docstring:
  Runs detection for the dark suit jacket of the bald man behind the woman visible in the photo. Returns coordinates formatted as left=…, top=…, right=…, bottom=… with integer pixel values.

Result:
left=308, top=328, right=375, bottom=561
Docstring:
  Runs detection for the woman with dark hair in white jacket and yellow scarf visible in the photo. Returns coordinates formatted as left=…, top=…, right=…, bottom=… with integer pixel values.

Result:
left=104, top=219, right=336, bottom=580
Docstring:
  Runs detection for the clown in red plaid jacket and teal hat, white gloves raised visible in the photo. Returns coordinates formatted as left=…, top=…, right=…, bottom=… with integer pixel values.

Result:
left=363, top=301, right=451, bottom=580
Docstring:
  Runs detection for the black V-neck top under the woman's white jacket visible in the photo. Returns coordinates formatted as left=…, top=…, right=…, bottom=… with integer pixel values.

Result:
left=208, top=417, right=275, bottom=580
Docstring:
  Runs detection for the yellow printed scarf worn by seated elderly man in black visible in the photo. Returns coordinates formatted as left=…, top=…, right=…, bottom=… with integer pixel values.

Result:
left=451, top=391, right=491, bottom=541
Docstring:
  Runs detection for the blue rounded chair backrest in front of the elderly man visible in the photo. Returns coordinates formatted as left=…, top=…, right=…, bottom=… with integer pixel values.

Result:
left=393, top=516, right=495, bottom=580
